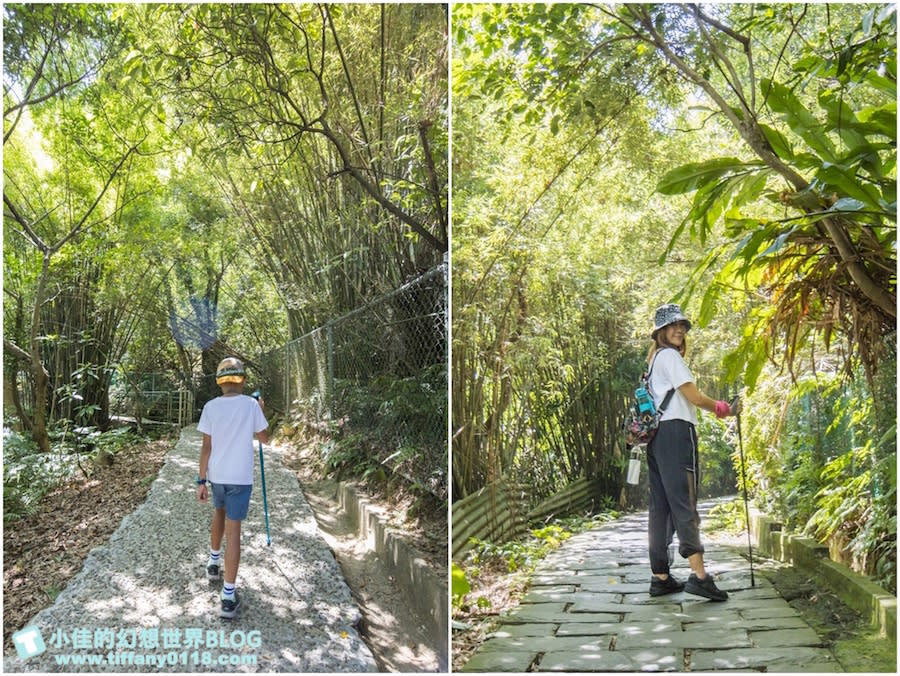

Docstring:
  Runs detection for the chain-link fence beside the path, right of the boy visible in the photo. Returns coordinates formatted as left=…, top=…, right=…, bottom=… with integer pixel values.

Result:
left=259, top=263, right=449, bottom=499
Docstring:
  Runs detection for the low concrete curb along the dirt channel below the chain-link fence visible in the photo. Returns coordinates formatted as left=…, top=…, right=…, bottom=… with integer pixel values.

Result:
left=337, top=482, right=449, bottom=671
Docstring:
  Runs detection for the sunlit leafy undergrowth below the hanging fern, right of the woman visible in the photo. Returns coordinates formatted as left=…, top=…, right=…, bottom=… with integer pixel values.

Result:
left=745, top=338, right=897, bottom=593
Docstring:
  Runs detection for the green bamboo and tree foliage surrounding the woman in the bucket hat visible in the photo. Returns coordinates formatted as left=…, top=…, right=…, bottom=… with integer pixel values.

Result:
left=451, top=4, right=896, bottom=584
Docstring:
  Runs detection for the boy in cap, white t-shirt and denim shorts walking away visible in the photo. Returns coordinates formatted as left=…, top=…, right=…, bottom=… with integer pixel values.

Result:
left=197, top=357, right=269, bottom=618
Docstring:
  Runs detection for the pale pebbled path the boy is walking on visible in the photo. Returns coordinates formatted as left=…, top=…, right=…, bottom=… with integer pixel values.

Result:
left=3, top=427, right=375, bottom=672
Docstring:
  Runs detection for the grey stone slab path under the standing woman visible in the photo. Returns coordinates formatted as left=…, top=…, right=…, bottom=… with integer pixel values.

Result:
left=462, top=502, right=842, bottom=673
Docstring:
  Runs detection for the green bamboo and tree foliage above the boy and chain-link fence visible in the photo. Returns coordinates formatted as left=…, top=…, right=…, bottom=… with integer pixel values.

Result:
left=3, top=4, right=449, bottom=452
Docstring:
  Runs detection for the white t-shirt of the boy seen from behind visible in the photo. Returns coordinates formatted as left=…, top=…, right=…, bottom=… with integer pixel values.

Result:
left=197, top=394, right=269, bottom=486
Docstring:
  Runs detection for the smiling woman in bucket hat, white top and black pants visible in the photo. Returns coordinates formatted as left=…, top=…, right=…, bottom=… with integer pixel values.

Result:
left=647, top=303, right=739, bottom=601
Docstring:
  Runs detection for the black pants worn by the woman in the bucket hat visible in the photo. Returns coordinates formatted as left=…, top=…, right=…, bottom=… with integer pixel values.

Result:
left=647, top=420, right=704, bottom=573
